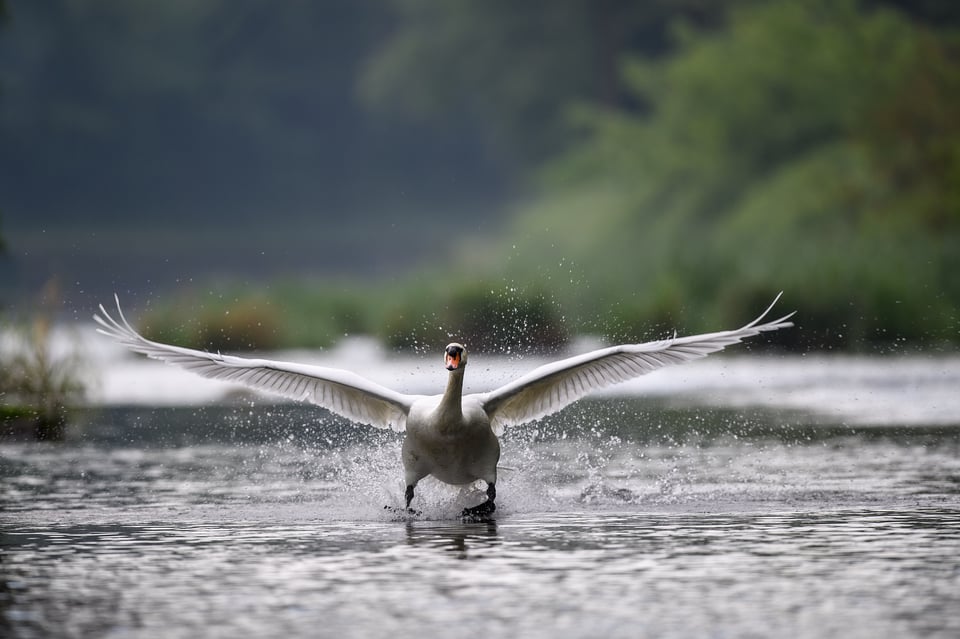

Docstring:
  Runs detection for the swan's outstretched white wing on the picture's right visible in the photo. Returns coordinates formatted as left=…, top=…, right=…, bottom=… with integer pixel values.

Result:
left=479, top=295, right=793, bottom=433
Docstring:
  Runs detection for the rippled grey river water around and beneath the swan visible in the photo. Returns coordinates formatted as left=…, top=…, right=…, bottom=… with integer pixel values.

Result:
left=0, top=357, right=960, bottom=638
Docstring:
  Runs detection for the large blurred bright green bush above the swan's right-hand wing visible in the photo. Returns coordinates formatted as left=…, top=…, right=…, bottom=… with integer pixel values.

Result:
left=492, top=0, right=960, bottom=347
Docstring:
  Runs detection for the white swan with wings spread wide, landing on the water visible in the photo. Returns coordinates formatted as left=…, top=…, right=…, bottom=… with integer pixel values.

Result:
left=94, top=293, right=794, bottom=518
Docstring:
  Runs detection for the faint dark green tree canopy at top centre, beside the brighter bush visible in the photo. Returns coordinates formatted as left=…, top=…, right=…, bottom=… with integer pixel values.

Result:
left=360, top=0, right=739, bottom=168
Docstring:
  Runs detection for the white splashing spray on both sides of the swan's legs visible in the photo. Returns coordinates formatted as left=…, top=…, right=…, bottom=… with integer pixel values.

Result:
left=248, top=401, right=683, bottom=521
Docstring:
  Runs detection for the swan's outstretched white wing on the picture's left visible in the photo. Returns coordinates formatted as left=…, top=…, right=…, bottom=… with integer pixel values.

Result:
left=93, top=300, right=415, bottom=431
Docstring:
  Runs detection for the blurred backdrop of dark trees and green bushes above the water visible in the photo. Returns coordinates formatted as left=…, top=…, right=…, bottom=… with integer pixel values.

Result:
left=0, top=0, right=960, bottom=353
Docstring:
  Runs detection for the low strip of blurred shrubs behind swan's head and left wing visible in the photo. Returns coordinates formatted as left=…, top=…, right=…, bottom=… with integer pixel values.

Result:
left=138, top=276, right=569, bottom=353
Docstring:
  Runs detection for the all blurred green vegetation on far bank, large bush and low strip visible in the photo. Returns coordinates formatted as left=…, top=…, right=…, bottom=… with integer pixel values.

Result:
left=137, top=0, right=960, bottom=352
